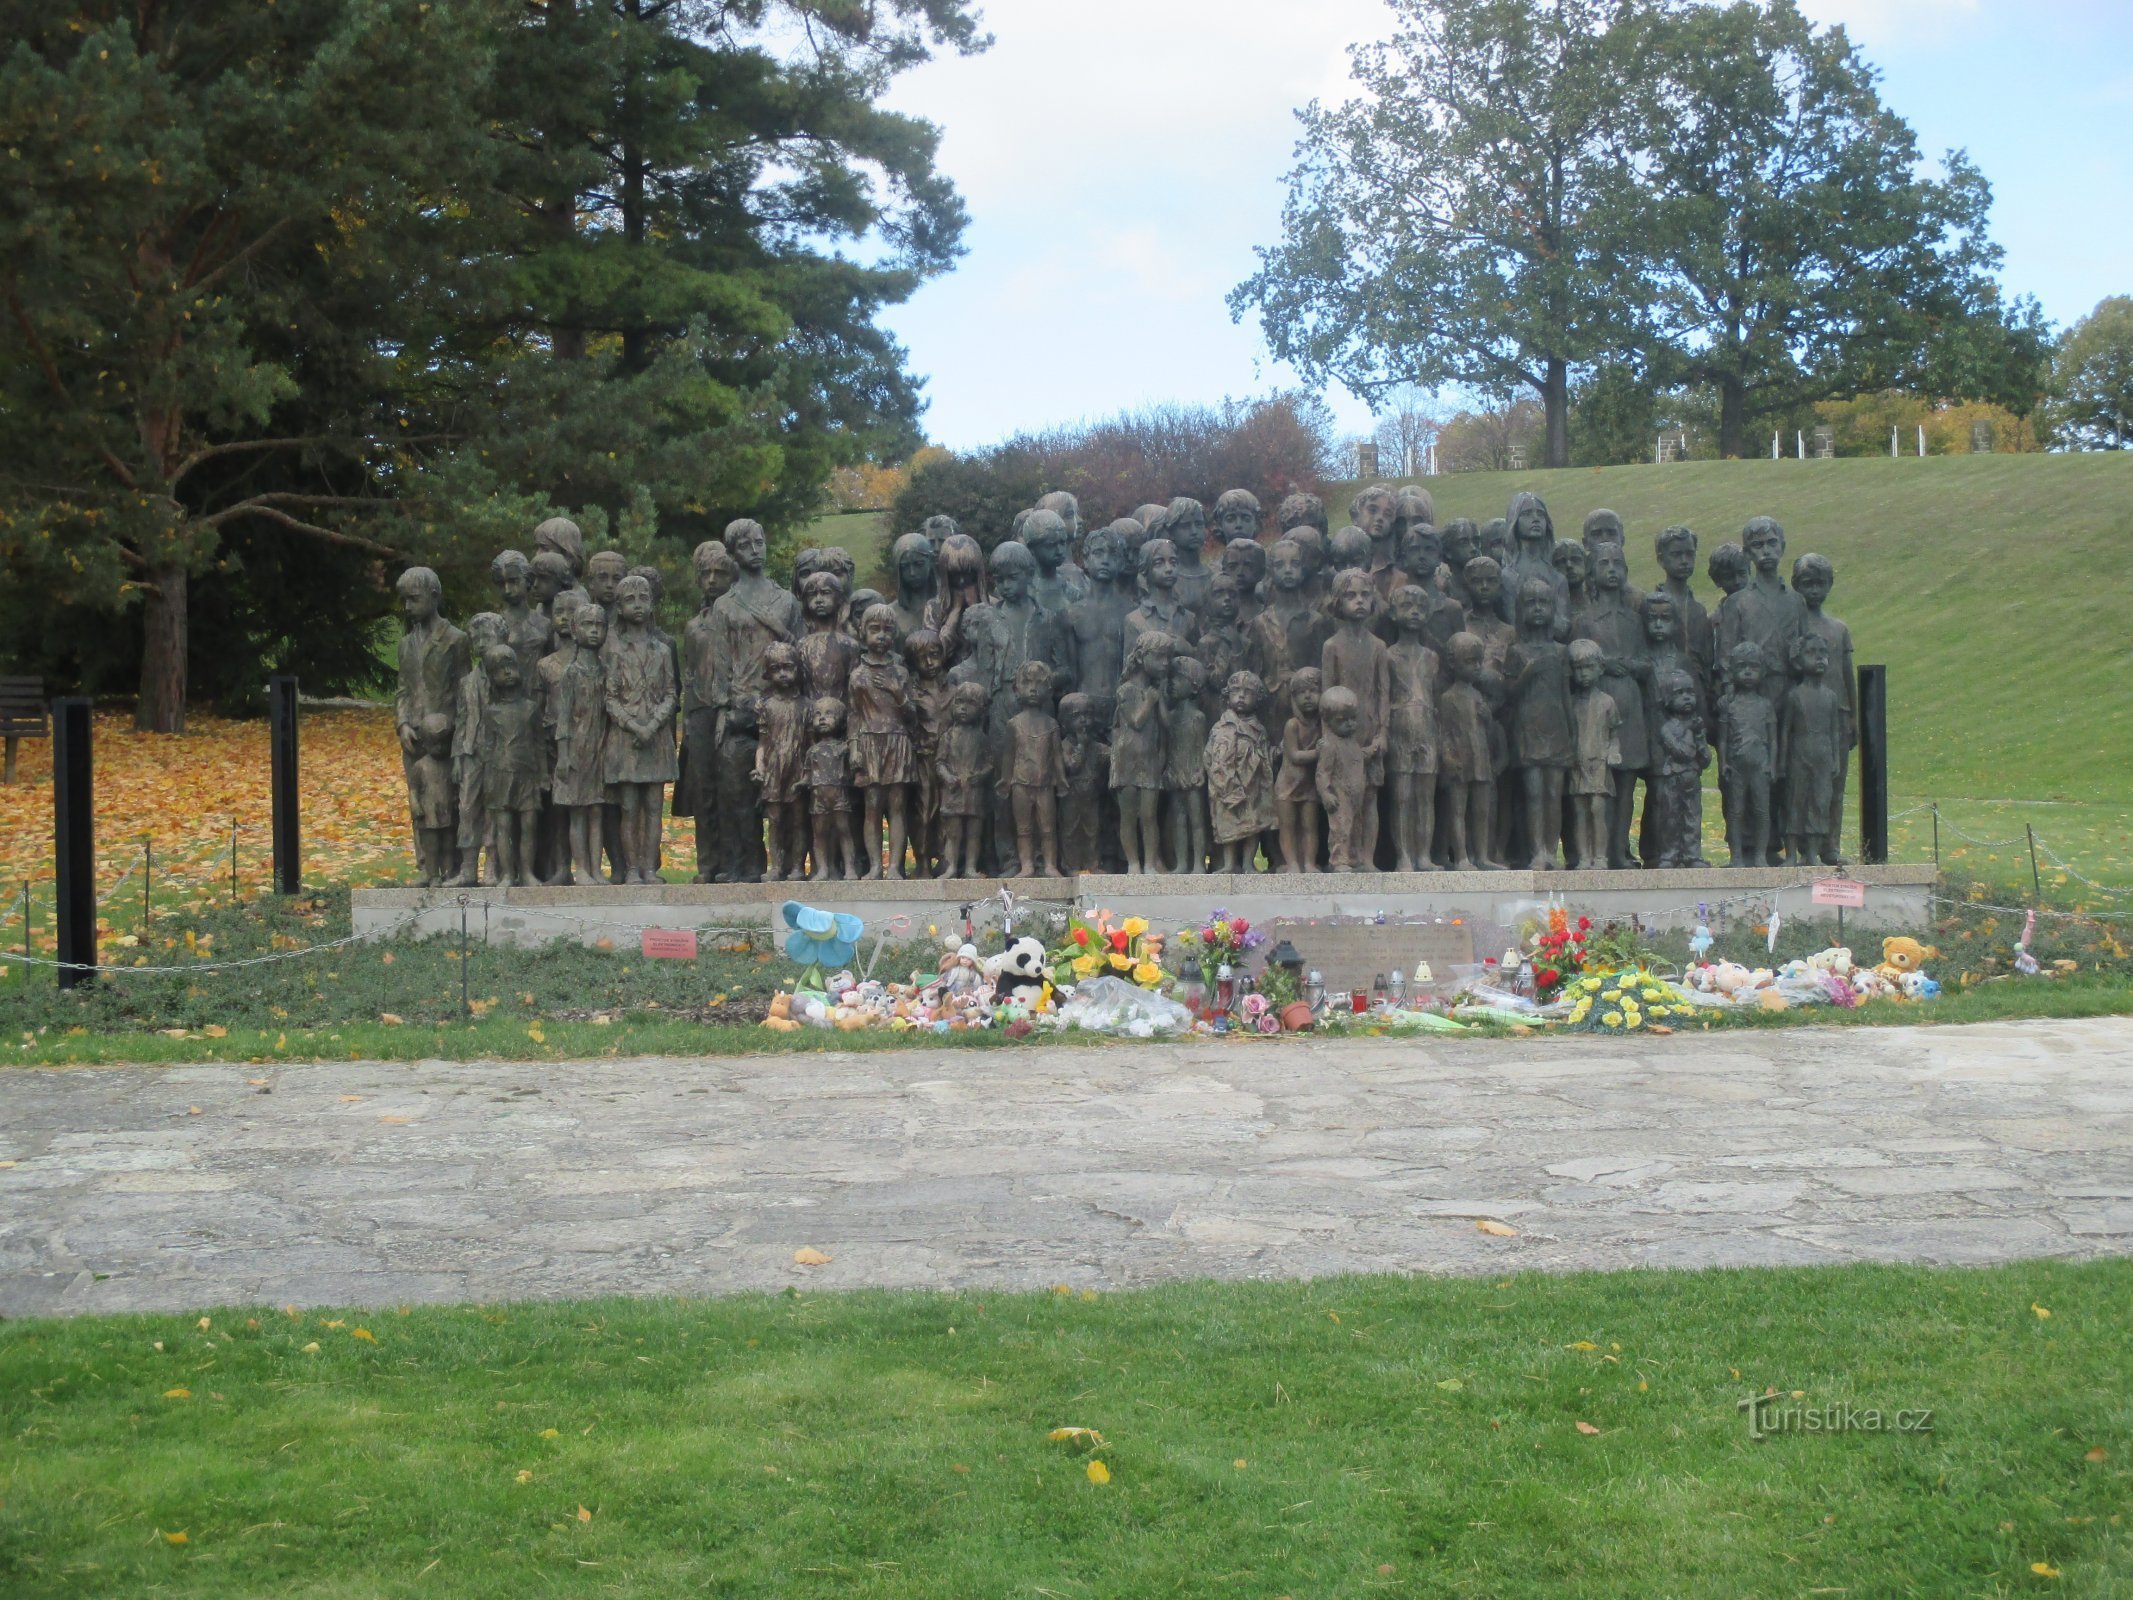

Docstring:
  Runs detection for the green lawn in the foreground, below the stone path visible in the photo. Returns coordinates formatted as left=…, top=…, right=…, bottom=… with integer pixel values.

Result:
left=0, top=1261, right=2133, bottom=1600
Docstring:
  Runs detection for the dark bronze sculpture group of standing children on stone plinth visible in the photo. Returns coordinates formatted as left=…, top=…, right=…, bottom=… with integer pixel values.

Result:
left=397, top=484, right=1856, bottom=885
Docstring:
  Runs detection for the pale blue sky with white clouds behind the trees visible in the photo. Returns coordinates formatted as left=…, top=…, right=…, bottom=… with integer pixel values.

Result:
left=887, top=0, right=2133, bottom=448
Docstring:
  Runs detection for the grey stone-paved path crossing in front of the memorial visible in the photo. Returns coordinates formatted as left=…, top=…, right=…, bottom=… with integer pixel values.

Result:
left=0, top=1020, right=2133, bottom=1316
